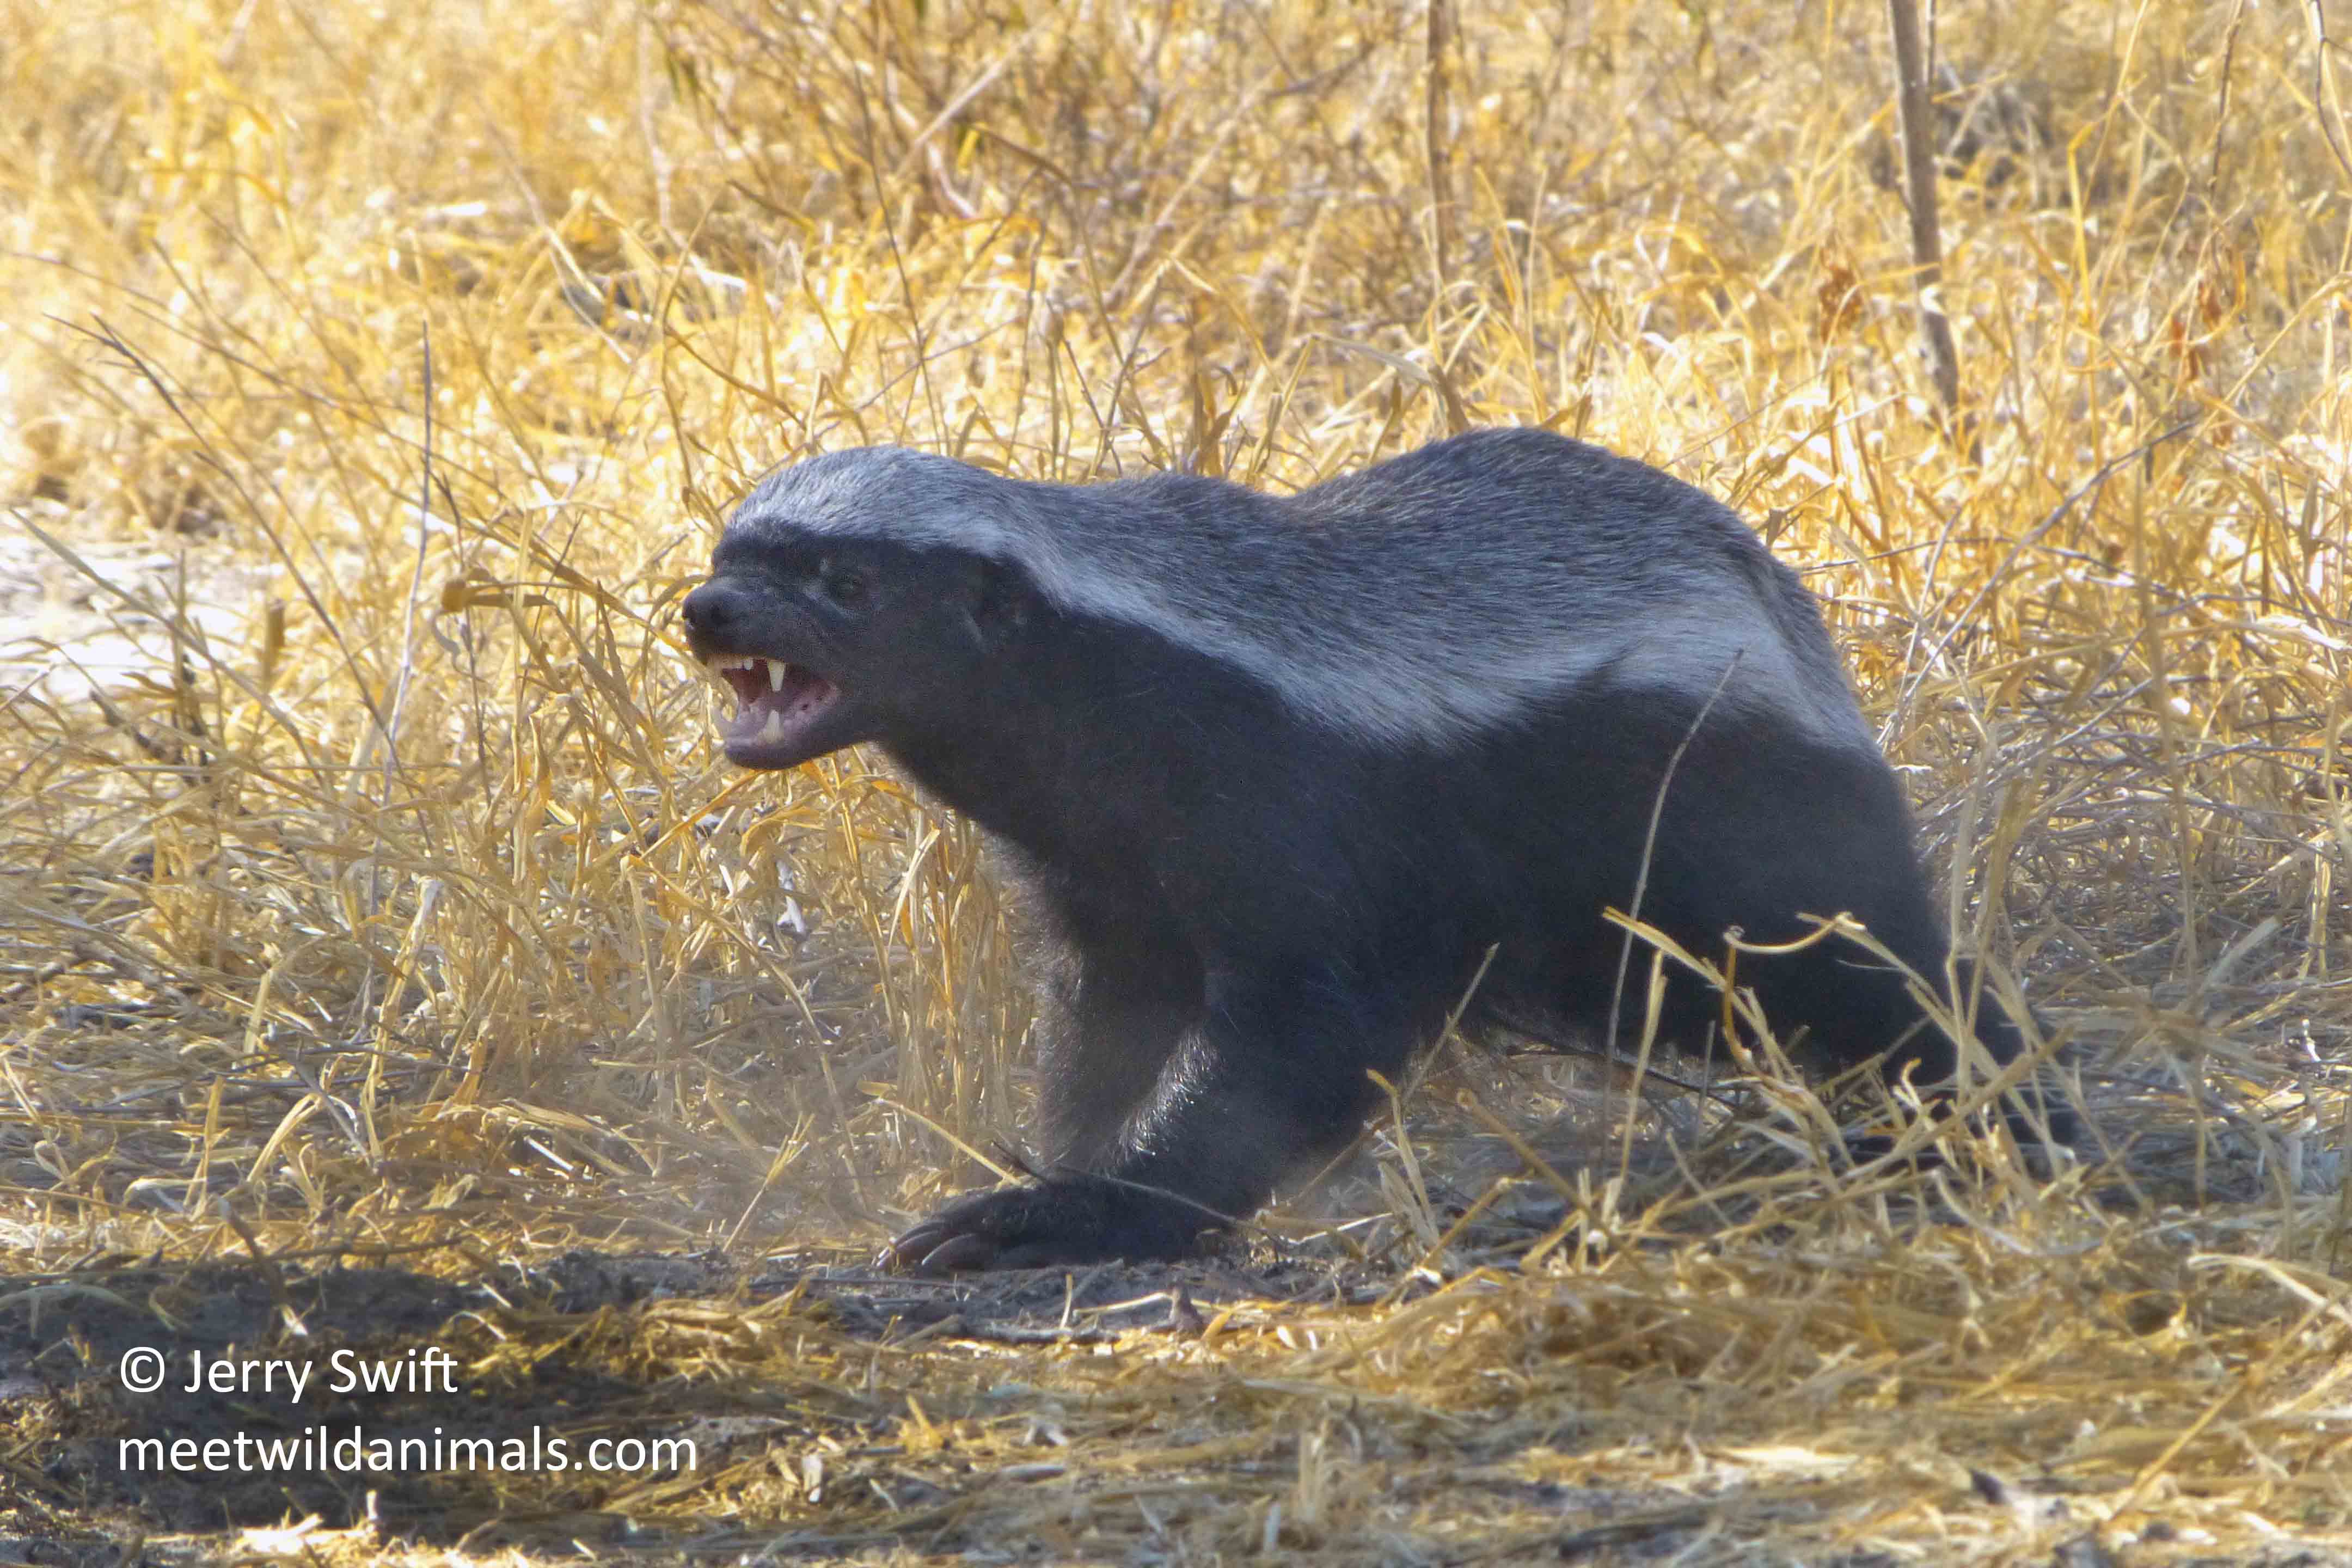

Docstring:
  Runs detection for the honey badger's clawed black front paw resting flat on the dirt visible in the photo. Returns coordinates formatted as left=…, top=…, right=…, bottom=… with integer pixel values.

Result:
left=877, top=1175, right=1221, bottom=1274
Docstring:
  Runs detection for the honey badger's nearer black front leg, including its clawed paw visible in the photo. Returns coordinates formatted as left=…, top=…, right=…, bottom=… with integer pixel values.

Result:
left=884, top=954, right=1430, bottom=1274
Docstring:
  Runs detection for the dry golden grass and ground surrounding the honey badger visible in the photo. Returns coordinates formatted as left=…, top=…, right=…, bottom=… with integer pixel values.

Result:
left=0, top=0, right=2352, bottom=1563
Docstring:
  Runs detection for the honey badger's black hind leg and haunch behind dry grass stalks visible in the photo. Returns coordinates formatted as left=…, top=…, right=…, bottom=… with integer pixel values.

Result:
left=1533, top=694, right=2079, bottom=1142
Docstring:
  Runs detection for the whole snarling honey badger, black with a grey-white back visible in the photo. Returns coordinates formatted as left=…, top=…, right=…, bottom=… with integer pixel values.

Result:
left=684, top=430, right=2063, bottom=1272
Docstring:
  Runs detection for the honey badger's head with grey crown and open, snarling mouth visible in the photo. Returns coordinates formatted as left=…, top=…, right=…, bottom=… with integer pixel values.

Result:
left=682, top=454, right=1019, bottom=769
